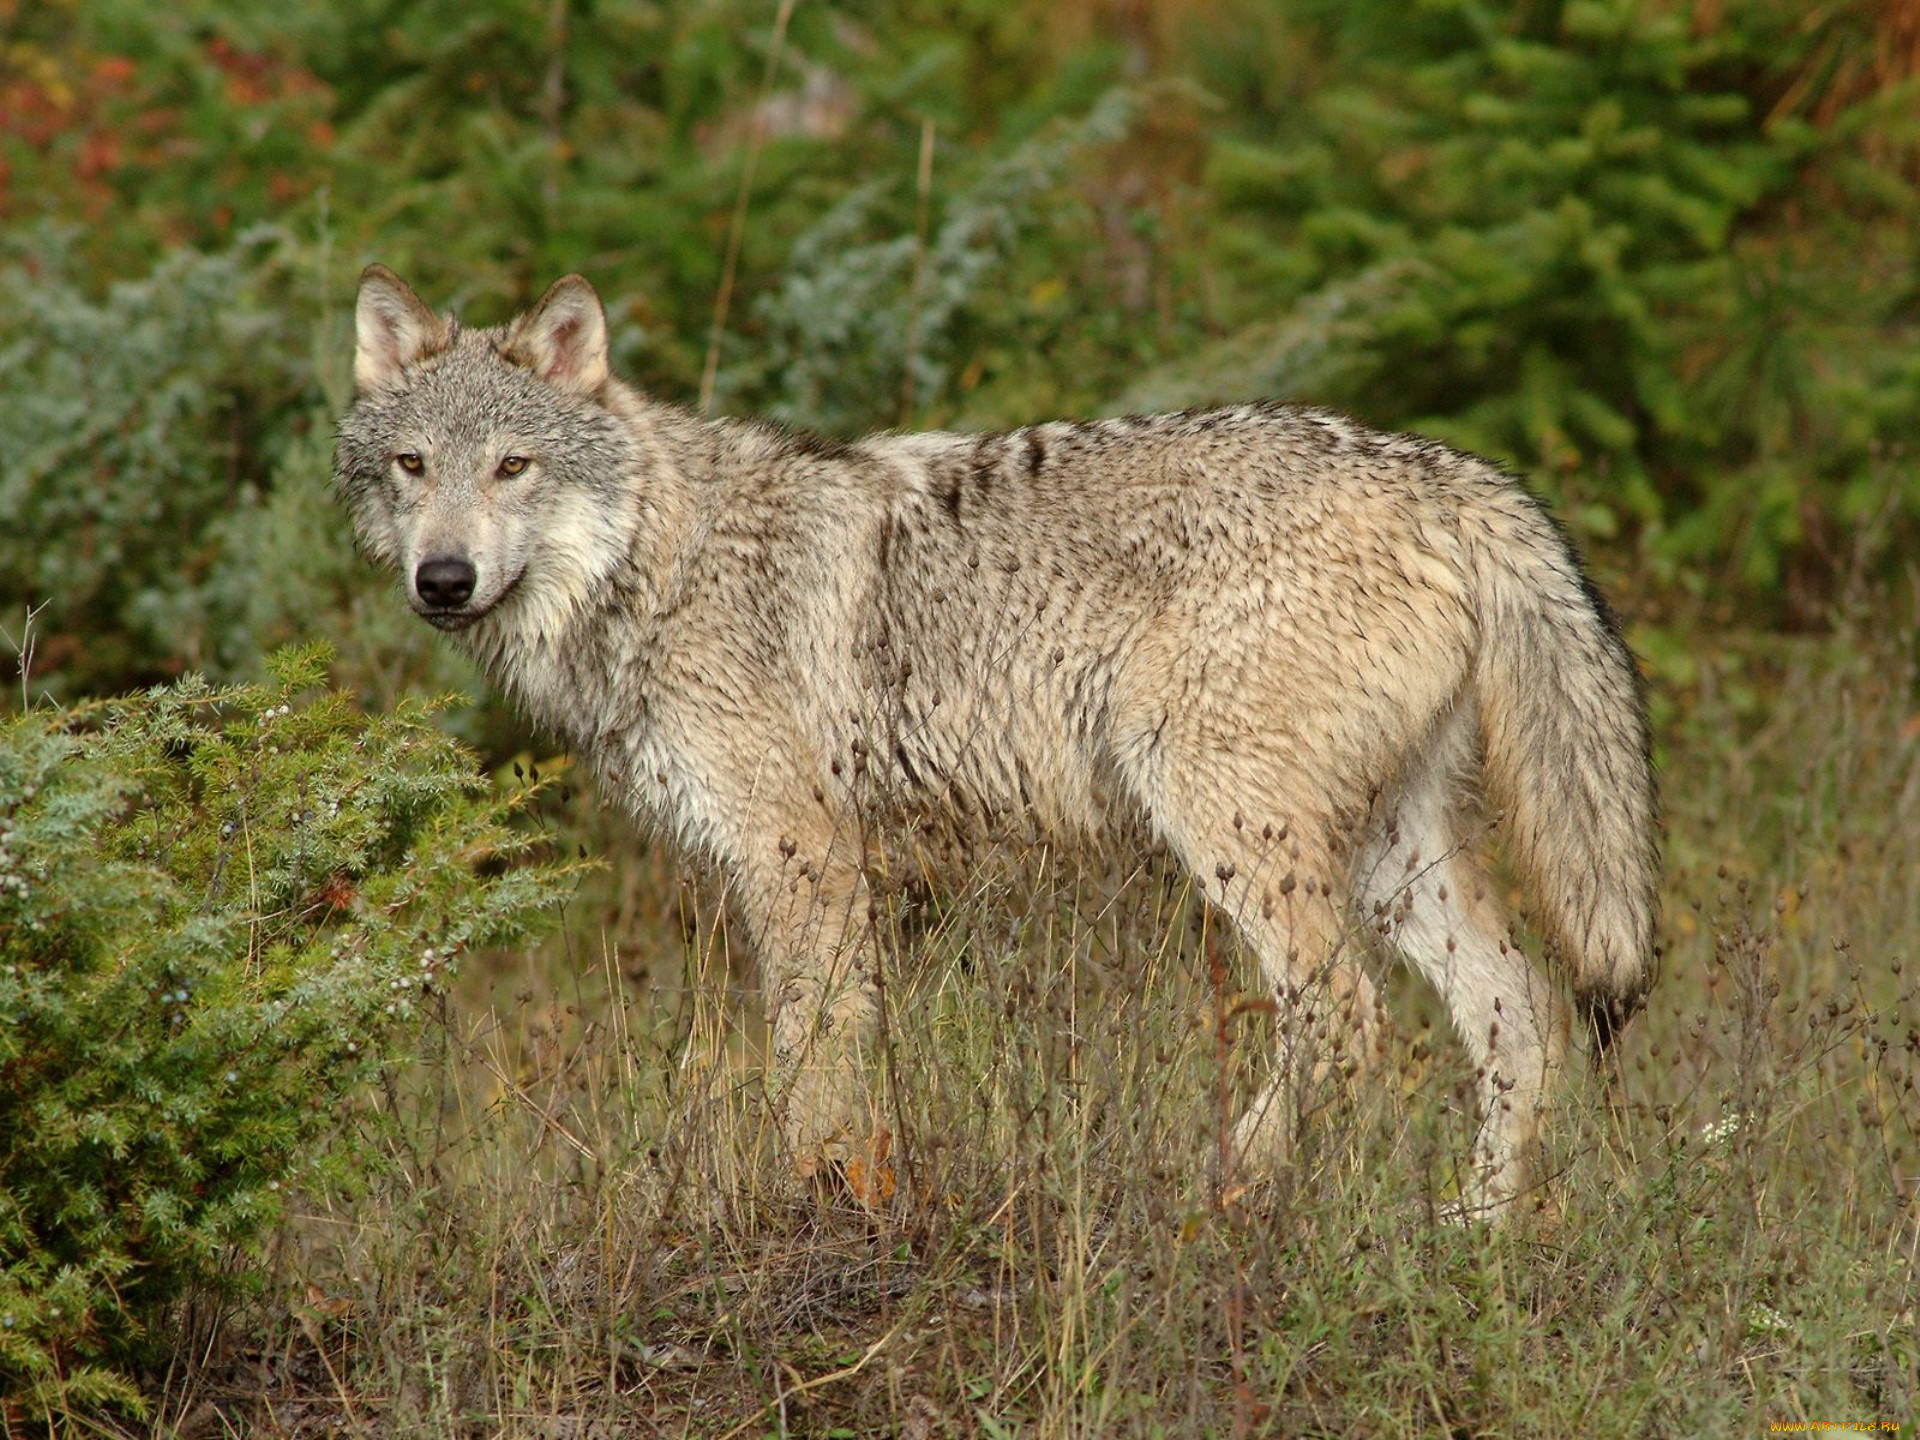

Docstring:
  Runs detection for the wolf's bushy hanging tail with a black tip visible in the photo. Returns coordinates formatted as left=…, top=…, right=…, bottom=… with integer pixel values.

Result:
left=1467, top=492, right=1659, bottom=1048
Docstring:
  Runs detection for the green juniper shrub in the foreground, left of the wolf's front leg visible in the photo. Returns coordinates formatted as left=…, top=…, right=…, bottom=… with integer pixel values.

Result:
left=0, top=647, right=572, bottom=1423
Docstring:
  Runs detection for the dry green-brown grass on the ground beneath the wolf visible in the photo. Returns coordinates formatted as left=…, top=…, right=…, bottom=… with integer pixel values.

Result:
left=139, top=618, right=1920, bottom=1440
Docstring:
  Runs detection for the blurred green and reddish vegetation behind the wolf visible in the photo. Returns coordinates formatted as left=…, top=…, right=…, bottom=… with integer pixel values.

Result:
left=0, top=0, right=1920, bottom=718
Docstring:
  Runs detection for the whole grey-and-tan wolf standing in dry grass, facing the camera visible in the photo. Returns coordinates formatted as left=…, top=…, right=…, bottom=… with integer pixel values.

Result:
left=336, top=267, right=1657, bottom=1204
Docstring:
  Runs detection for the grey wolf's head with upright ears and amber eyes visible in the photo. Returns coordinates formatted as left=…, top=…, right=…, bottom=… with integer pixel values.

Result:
left=334, top=265, right=636, bottom=634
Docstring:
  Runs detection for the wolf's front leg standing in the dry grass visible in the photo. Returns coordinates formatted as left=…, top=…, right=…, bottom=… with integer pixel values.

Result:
left=745, top=837, right=885, bottom=1202
